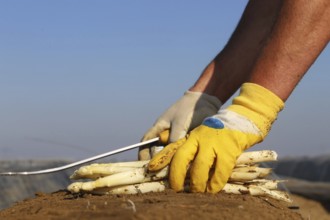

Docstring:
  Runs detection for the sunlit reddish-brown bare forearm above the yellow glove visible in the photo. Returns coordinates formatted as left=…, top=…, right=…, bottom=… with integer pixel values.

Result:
left=249, top=0, right=330, bottom=101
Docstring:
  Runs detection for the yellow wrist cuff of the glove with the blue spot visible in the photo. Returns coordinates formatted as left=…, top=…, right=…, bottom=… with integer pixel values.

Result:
left=227, top=83, right=284, bottom=138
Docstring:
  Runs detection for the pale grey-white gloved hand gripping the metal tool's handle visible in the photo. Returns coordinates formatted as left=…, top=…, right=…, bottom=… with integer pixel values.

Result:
left=139, top=91, right=221, bottom=160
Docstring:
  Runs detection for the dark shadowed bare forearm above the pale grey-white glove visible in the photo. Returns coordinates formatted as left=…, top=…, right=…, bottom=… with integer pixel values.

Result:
left=190, top=0, right=281, bottom=103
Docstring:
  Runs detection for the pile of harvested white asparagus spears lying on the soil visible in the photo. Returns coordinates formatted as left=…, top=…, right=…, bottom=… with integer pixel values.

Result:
left=68, top=150, right=291, bottom=202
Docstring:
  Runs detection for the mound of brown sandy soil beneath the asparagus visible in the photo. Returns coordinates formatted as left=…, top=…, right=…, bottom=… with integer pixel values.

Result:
left=0, top=190, right=306, bottom=220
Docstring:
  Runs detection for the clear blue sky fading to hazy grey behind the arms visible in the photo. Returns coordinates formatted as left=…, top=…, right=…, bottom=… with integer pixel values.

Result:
left=0, top=0, right=330, bottom=160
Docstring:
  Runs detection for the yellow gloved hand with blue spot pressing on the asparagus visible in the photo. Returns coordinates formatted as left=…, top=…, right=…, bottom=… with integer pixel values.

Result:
left=149, top=83, right=284, bottom=193
